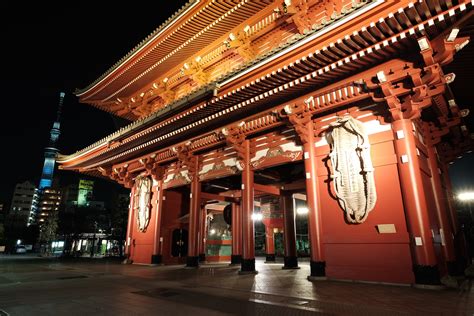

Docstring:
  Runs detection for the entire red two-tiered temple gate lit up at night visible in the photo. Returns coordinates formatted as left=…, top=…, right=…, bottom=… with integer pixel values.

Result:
left=58, top=0, right=472, bottom=286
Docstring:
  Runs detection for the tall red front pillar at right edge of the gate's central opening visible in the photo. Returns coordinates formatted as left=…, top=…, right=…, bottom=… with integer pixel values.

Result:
left=240, top=139, right=257, bottom=273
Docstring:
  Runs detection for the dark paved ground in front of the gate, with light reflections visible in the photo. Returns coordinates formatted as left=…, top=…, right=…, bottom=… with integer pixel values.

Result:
left=0, top=256, right=474, bottom=316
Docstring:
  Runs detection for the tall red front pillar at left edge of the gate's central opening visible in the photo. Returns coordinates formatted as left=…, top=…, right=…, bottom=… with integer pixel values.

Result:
left=186, top=157, right=201, bottom=267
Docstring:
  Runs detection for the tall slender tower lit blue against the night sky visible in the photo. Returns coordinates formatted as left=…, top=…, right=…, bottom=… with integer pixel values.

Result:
left=38, top=92, right=64, bottom=191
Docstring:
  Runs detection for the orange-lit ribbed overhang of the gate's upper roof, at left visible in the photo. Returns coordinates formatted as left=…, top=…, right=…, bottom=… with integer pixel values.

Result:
left=77, top=0, right=271, bottom=107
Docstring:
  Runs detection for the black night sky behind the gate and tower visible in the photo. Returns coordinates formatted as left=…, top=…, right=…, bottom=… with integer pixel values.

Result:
left=0, top=0, right=474, bottom=203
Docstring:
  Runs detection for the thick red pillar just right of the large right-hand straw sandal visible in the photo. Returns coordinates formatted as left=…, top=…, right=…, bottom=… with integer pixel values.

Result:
left=392, top=119, right=440, bottom=285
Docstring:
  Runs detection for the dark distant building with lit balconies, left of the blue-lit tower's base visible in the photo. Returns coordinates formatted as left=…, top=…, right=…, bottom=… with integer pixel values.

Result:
left=8, top=181, right=38, bottom=226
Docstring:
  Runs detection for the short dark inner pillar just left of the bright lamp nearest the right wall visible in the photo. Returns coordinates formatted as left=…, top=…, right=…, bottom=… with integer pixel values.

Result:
left=280, top=195, right=299, bottom=269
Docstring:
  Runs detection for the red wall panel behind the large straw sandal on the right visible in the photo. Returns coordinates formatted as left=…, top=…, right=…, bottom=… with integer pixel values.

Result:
left=318, top=131, right=414, bottom=283
